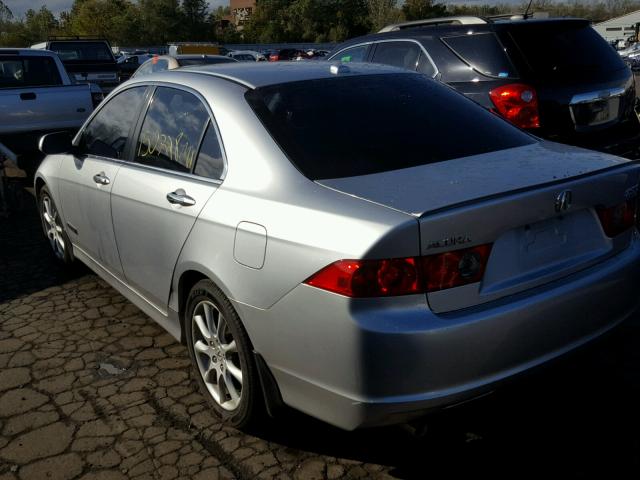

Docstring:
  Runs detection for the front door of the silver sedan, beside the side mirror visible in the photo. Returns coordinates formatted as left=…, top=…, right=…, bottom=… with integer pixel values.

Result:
left=60, top=87, right=146, bottom=274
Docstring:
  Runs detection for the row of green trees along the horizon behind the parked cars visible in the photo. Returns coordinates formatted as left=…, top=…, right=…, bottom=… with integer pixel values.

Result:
left=0, top=0, right=640, bottom=47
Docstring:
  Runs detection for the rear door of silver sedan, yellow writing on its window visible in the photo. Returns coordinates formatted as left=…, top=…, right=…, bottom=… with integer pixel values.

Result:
left=111, top=86, right=224, bottom=314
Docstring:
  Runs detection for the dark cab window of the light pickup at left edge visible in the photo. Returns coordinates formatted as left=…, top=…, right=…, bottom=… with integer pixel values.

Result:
left=0, top=55, right=62, bottom=88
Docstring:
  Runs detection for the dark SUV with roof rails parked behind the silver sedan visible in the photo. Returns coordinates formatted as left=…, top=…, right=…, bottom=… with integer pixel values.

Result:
left=328, top=17, right=640, bottom=158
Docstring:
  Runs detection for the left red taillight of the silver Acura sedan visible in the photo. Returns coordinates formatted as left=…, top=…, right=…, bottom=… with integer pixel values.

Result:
left=304, top=245, right=491, bottom=297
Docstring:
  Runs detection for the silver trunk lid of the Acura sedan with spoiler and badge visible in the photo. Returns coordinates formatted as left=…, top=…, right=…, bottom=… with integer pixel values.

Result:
left=319, top=142, right=638, bottom=312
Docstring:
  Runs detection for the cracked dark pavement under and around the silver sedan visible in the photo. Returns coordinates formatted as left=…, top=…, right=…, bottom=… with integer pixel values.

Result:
left=0, top=197, right=640, bottom=480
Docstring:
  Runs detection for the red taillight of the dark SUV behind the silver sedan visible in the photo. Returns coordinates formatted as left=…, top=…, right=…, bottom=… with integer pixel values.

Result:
left=489, top=83, right=540, bottom=128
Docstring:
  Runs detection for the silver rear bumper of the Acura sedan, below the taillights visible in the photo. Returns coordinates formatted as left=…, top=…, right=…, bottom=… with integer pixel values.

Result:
left=238, top=235, right=640, bottom=429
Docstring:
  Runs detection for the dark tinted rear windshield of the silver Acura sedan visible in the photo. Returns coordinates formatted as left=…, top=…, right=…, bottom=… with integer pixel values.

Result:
left=245, top=73, right=534, bottom=180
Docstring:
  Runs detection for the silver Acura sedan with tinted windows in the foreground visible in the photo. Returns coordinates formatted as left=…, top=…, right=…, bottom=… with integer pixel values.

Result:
left=35, top=62, right=640, bottom=429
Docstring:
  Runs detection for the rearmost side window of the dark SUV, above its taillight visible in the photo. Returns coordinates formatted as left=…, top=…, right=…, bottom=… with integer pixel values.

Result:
left=442, top=33, right=517, bottom=78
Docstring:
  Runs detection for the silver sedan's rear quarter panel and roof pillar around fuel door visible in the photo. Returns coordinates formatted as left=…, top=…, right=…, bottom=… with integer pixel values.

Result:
left=170, top=72, right=420, bottom=334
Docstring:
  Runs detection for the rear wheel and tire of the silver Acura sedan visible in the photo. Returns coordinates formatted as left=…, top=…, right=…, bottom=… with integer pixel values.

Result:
left=185, top=280, right=264, bottom=428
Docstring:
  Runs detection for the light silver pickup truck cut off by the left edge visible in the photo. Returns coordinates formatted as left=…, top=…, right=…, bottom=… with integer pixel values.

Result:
left=0, top=48, right=103, bottom=169
